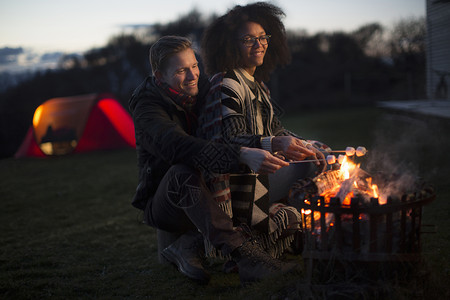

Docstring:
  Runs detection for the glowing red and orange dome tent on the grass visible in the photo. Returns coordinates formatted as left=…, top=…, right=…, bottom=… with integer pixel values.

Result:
left=14, top=94, right=136, bottom=158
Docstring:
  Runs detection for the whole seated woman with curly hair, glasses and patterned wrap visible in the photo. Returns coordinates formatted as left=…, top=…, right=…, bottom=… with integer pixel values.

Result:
left=200, top=2, right=326, bottom=264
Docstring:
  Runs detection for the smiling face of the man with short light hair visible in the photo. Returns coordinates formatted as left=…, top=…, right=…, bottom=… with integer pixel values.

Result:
left=155, top=49, right=200, bottom=96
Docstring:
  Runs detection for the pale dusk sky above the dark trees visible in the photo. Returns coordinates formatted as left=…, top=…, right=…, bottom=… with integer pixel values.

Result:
left=0, top=0, right=425, bottom=52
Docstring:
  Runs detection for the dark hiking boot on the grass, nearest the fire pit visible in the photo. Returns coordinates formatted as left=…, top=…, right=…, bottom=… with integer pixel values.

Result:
left=231, top=239, right=298, bottom=285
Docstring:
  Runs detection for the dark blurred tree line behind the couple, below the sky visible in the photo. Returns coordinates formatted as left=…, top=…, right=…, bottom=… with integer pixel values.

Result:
left=0, top=10, right=426, bottom=158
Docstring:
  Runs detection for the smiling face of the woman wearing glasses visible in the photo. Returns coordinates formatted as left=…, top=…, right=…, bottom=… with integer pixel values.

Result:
left=238, top=22, right=268, bottom=75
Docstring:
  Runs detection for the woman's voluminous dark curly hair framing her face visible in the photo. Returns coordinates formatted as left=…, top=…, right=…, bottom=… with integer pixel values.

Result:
left=201, top=2, right=291, bottom=81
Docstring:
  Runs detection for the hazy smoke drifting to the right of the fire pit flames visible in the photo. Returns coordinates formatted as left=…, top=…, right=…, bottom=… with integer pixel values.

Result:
left=366, top=114, right=448, bottom=197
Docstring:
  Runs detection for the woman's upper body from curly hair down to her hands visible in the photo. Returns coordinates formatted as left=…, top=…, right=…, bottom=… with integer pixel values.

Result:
left=202, top=2, right=324, bottom=173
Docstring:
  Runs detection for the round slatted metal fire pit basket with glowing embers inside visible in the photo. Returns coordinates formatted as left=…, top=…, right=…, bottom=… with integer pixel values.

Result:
left=289, top=172, right=435, bottom=262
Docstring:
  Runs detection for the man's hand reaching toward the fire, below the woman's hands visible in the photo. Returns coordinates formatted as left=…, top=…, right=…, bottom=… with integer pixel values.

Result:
left=240, top=147, right=289, bottom=174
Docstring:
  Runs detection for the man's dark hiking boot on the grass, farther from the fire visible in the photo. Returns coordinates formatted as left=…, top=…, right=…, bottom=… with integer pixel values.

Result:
left=161, top=232, right=211, bottom=284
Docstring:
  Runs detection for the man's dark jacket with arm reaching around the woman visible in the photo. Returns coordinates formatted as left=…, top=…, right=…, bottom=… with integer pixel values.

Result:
left=129, top=76, right=240, bottom=209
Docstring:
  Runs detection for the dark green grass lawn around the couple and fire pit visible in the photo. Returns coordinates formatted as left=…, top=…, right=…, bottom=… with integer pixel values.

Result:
left=0, top=108, right=450, bottom=299
